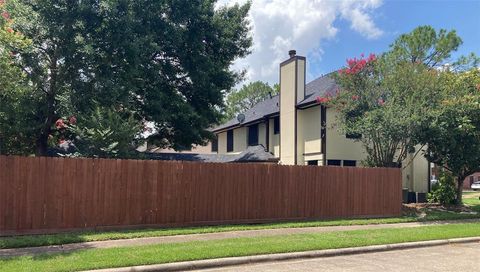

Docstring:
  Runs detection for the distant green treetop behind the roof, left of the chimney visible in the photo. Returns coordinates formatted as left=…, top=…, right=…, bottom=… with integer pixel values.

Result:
left=224, top=81, right=279, bottom=121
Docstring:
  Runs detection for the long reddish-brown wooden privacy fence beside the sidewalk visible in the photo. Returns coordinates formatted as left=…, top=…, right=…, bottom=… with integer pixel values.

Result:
left=0, top=156, right=402, bottom=235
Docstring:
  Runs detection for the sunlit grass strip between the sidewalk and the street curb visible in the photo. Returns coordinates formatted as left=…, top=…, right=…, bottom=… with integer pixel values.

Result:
left=0, top=223, right=480, bottom=271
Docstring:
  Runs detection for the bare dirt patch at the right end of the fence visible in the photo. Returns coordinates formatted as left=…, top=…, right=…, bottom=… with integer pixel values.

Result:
left=402, top=203, right=478, bottom=218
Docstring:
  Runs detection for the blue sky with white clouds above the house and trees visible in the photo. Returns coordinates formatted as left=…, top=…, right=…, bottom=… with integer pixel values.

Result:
left=221, top=0, right=480, bottom=84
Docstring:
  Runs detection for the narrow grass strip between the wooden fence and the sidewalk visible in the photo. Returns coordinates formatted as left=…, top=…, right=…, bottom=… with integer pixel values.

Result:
left=0, top=193, right=480, bottom=251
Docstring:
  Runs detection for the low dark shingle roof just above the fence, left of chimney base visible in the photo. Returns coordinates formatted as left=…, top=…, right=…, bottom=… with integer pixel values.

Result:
left=146, top=145, right=277, bottom=163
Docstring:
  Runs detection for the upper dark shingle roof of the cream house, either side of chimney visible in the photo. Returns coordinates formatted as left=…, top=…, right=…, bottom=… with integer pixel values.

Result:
left=213, top=74, right=338, bottom=131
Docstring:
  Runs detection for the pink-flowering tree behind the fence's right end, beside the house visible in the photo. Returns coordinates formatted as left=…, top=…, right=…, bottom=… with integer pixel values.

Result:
left=317, top=51, right=437, bottom=167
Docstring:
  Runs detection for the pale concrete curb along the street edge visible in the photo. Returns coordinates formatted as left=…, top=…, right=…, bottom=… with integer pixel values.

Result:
left=89, top=237, right=480, bottom=272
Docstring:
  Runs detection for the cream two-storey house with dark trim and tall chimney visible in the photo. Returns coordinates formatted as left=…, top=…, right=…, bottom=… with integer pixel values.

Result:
left=212, top=50, right=430, bottom=198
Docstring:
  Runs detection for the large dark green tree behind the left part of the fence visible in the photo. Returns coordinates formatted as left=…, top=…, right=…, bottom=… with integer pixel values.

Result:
left=2, top=0, right=251, bottom=155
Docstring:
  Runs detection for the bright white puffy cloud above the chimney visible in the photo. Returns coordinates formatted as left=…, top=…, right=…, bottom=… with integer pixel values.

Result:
left=217, top=0, right=382, bottom=83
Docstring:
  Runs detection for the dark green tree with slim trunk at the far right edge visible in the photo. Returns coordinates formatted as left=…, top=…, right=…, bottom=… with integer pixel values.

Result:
left=417, top=69, right=480, bottom=204
